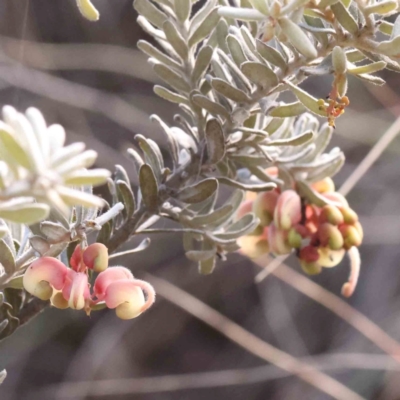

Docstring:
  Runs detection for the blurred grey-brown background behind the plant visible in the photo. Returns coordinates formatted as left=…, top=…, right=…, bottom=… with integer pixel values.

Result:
left=0, top=0, right=400, bottom=400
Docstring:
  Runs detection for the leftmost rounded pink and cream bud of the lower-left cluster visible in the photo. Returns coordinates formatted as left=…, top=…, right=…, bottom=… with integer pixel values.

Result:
left=23, top=257, right=68, bottom=300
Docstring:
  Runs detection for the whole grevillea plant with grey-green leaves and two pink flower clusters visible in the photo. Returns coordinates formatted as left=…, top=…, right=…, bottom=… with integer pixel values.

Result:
left=0, top=0, right=400, bottom=384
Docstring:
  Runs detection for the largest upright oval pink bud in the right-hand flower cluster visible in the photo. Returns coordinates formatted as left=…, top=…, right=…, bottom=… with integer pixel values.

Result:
left=274, top=190, right=301, bottom=230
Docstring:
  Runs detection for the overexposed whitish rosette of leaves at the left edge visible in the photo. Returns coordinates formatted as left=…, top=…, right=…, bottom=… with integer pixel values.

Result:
left=0, top=106, right=110, bottom=222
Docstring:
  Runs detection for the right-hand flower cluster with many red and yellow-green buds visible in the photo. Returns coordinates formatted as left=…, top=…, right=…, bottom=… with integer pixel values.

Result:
left=237, top=178, right=363, bottom=274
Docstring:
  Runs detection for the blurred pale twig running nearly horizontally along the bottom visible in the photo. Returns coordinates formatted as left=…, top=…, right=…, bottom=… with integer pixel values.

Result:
left=40, top=353, right=400, bottom=399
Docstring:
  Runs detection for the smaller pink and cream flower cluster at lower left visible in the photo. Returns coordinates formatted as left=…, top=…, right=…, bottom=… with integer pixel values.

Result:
left=23, top=243, right=155, bottom=319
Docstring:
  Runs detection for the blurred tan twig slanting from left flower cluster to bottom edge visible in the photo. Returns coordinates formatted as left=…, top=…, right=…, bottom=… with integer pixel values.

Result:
left=146, top=274, right=362, bottom=400
